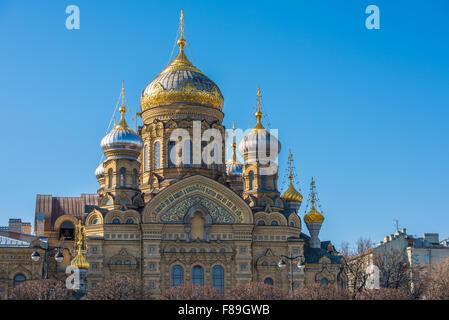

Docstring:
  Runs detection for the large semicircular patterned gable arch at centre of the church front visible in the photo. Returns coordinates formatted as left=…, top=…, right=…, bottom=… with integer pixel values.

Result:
left=143, top=175, right=253, bottom=224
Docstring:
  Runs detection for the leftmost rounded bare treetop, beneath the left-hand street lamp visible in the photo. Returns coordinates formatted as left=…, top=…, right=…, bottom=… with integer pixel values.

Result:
left=11, top=279, right=73, bottom=300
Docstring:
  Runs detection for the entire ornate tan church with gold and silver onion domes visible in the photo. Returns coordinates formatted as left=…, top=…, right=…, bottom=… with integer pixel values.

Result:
left=0, top=11, right=341, bottom=294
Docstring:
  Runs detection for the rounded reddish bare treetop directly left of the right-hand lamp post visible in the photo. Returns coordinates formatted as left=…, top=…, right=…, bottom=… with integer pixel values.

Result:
left=227, top=282, right=285, bottom=300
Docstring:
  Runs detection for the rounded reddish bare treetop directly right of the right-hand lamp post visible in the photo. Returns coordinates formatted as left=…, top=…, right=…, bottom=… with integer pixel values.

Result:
left=288, top=283, right=350, bottom=300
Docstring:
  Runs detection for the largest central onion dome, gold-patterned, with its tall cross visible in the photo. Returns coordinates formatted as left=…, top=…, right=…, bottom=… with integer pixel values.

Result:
left=140, top=11, right=223, bottom=112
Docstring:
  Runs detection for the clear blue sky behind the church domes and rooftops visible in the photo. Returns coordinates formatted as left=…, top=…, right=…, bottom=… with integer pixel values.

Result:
left=0, top=0, right=449, bottom=246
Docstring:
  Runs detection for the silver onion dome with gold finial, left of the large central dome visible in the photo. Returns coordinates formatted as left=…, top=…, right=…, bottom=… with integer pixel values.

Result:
left=100, top=105, right=143, bottom=157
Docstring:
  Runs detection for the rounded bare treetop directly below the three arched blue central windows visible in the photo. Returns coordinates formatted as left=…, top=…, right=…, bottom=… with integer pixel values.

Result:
left=161, top=285, right=223, bottom=300
